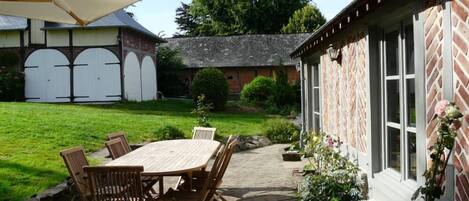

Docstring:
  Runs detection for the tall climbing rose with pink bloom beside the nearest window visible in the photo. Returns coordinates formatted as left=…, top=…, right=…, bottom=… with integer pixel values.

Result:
left=412, top=100, right=467, bottom=201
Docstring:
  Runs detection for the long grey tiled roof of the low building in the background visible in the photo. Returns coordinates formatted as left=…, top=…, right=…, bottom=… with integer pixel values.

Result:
left=163, top=33, right=310, bottom=68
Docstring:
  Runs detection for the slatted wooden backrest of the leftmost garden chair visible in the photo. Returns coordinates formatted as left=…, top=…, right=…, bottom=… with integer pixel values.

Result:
left=60, top=147, right=90, bottom=200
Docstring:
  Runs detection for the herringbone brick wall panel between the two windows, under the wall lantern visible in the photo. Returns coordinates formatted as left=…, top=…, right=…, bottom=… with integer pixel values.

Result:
left=320, top=31, right=367, bottom=153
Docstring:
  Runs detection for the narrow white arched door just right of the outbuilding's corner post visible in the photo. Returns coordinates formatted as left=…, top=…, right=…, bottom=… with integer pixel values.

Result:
left=124, top=52, right=142, bottom=101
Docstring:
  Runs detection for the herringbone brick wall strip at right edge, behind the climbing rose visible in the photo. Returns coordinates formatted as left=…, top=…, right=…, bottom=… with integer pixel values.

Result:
left=451, top=0, right=469, bottom=201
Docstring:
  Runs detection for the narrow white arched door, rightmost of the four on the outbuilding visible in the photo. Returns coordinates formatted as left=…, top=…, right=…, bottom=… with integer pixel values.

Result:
left=142, top=56, right=157, bottom=101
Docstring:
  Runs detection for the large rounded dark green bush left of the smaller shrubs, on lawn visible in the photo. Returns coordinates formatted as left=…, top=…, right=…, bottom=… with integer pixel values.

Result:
left=192, top=68, right=228, bottom=111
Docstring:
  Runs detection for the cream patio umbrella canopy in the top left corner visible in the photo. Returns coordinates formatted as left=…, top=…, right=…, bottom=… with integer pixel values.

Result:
left=0, top=0, right=139, bottom=26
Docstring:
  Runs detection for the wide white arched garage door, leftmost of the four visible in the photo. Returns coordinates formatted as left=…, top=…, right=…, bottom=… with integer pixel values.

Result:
left=24, top=49, right=70, bottom=102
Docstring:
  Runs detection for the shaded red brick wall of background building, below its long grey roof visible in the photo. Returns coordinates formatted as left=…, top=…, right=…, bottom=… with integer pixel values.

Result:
left=182, top=66, right=299, bottom=94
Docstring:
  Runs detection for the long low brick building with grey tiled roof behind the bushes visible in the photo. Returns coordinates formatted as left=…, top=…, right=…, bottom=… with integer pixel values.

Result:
left=164, top=34, right=308, bottom=94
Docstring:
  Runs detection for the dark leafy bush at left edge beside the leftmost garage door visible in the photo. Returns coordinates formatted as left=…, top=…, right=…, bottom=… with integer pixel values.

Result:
left=0, top=52, right=24, bottom=101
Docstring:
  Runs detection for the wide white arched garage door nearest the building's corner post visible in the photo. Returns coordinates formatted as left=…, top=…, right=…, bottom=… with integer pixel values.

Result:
left=73, top=48, right=121, bottom=102
